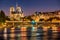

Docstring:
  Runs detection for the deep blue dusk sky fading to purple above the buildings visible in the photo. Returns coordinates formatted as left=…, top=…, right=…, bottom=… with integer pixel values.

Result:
left=0, top=0, right=60, bottom=16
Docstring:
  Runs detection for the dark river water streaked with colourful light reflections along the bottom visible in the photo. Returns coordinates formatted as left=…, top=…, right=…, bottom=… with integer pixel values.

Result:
left=0, top=26, right=60, bottom=40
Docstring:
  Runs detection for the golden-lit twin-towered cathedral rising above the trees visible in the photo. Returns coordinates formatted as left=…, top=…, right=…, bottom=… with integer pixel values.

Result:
left=10, top=5, right=24, bottom=20
